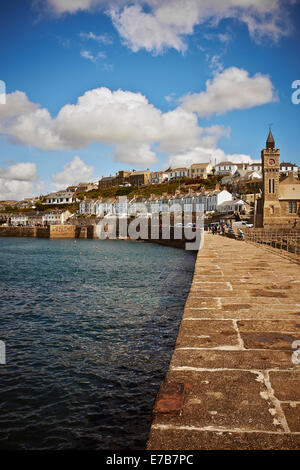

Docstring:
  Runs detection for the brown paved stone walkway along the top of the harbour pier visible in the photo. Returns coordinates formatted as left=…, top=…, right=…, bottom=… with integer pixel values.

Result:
left=147, top=234, right=300, bottom=450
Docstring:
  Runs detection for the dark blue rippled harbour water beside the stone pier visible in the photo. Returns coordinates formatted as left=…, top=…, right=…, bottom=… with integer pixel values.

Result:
left=0, top=238, right=195, bottom=449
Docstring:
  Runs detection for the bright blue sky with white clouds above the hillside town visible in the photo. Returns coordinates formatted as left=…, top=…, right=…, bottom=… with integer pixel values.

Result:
left=0, top=0, right=300, bottom=200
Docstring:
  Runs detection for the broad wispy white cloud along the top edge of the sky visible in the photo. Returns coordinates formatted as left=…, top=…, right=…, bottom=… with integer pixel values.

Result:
left=42, top=0, right=296, bottom=53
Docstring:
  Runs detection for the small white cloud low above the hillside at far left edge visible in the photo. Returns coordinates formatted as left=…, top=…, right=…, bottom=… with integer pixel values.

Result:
left=0, top=162, right=44, bottom=201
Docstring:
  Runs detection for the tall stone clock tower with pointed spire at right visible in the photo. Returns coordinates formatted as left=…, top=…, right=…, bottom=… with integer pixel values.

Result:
left=261, top=129, right=281, bottom=226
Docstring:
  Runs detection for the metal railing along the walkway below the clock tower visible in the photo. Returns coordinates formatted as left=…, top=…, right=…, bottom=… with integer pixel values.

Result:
left=243, top=228, right=300, bottom=262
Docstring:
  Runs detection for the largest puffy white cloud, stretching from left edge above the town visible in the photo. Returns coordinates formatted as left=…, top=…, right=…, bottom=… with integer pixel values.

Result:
left=0, top=87, right=227, bottom=166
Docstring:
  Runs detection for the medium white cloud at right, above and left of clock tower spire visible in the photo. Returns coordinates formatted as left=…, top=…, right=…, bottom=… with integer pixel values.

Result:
left=181, top=67, right=276, bottom=117
